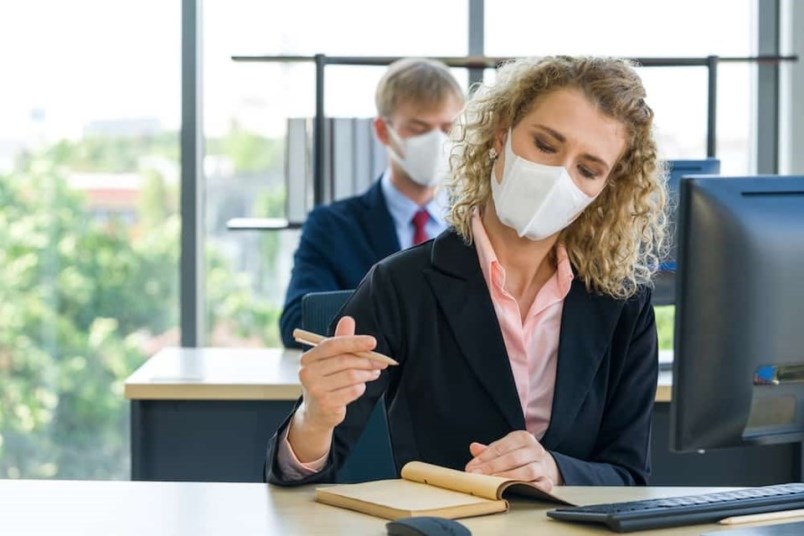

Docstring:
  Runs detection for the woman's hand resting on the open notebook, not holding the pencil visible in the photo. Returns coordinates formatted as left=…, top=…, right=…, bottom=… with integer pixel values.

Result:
left=466, top=430, right=562, bottom=491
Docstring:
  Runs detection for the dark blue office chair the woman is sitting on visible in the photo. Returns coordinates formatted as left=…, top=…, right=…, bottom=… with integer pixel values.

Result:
left=301, top=290, right=397, bottom=483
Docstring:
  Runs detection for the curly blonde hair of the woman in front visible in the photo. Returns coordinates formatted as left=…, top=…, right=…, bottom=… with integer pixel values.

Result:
left=447, top=56, right=667, bottom=299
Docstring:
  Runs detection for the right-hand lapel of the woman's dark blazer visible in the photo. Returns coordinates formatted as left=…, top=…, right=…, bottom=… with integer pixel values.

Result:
left=542, top=279, right=623, bottom=448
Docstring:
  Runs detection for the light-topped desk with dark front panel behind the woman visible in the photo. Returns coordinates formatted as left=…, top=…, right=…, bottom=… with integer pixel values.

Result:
left=125, top=348, right=801, bottom=486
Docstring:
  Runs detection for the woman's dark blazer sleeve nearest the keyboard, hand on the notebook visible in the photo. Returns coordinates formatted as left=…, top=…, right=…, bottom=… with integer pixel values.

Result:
left=550, top=288, right=659, bottom=486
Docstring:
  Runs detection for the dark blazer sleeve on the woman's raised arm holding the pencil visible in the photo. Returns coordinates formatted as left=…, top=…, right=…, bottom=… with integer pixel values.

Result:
left=264, top=264, right=404, bottom=486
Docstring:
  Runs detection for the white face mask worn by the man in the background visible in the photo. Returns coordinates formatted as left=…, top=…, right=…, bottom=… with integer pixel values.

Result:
left=388, top=125, right=449, bottom=186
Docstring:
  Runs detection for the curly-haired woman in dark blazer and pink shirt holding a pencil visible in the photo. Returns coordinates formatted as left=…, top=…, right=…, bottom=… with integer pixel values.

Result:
left=266, top=57, right=665, bottom=490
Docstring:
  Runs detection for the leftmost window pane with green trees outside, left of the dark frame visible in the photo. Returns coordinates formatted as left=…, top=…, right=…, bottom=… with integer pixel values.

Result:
left=0, top=0, right=180, bottom=479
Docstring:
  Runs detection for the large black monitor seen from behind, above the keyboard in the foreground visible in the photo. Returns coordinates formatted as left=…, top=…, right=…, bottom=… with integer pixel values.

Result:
left=670, top=176, right=804, bottom=452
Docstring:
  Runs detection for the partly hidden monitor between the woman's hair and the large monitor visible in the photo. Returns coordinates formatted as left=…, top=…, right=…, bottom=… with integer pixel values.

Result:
left=652, top=158, right=720, bottom=305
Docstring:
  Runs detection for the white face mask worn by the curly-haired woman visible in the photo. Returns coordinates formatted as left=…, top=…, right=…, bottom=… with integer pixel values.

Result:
left=491, top=129, right=595, bottom=240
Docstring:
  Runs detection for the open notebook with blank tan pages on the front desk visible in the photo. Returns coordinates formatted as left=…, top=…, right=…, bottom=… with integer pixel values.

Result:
left=315, top=462, right=574, bottom=519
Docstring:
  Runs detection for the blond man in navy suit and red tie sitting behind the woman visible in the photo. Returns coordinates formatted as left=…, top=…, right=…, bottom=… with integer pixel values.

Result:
left=279, top=59, right=464, bottom=347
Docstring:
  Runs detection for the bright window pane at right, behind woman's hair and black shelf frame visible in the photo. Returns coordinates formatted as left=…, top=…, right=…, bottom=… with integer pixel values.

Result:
left=485, top=0, right=756, bottom=349
